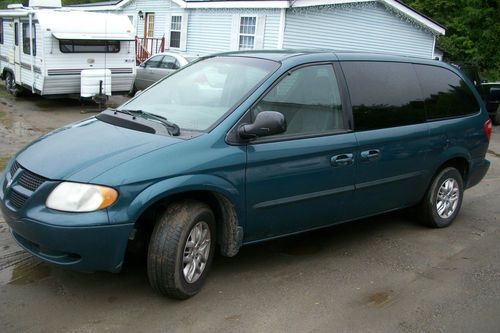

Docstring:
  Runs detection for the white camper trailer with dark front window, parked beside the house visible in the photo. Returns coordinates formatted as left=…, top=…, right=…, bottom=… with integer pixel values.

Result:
left=0, top=0, right=135, bottom=97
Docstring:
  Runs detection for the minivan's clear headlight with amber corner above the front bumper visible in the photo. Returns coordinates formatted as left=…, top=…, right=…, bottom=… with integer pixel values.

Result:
left=45, top=182, right=118, bottom=212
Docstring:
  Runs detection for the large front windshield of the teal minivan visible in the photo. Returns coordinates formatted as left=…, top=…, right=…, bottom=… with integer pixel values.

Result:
left=119, top=57, right=279, bottom=131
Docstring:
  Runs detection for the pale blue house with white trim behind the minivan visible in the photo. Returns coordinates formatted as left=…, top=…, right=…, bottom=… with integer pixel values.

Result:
left=70, top=0, right=445, bottom=62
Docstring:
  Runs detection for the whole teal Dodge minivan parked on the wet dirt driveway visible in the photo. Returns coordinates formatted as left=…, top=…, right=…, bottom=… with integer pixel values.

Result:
left=0, top=51, right=491, bottom=299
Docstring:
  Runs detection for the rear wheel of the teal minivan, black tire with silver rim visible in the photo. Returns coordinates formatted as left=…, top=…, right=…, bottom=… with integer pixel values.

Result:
left=419, top=167, right=464, bottom=228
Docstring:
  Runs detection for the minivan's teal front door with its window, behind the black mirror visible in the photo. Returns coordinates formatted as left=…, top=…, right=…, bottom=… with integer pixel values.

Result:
left=245, top=64, right=357, bottom=242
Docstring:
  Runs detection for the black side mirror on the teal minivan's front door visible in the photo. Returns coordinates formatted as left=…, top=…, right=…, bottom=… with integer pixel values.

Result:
left=238, top=111, right=286, bottom=139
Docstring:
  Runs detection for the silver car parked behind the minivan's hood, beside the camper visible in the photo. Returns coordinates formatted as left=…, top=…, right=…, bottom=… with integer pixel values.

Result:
left=132, top=52, right=197, bottom=93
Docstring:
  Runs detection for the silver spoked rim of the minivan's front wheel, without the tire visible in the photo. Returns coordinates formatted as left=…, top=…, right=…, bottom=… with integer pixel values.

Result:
left=182, top=221, right=210, bottom=283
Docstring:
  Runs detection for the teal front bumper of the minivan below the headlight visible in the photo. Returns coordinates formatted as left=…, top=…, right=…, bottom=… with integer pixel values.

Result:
left=0, top=175, right=134, bottom=272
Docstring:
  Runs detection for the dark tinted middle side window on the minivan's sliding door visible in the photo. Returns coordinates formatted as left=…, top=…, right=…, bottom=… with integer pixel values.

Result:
left=342, top=61, right=425, bottom=131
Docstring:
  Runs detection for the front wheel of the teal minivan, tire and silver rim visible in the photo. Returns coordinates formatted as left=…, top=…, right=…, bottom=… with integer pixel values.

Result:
left=147, top=200, right=216, bottom=299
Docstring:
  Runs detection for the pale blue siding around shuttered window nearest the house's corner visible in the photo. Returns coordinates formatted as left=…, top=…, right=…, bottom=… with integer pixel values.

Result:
left=187, top=9, right=280, bottom=55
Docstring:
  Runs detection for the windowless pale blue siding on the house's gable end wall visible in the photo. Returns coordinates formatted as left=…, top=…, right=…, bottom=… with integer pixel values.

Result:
left=283, top=2, right=434, bottom=58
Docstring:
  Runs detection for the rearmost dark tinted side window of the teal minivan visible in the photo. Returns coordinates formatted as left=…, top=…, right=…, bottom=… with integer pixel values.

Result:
left=415, top=65, right=479, bottom=119
